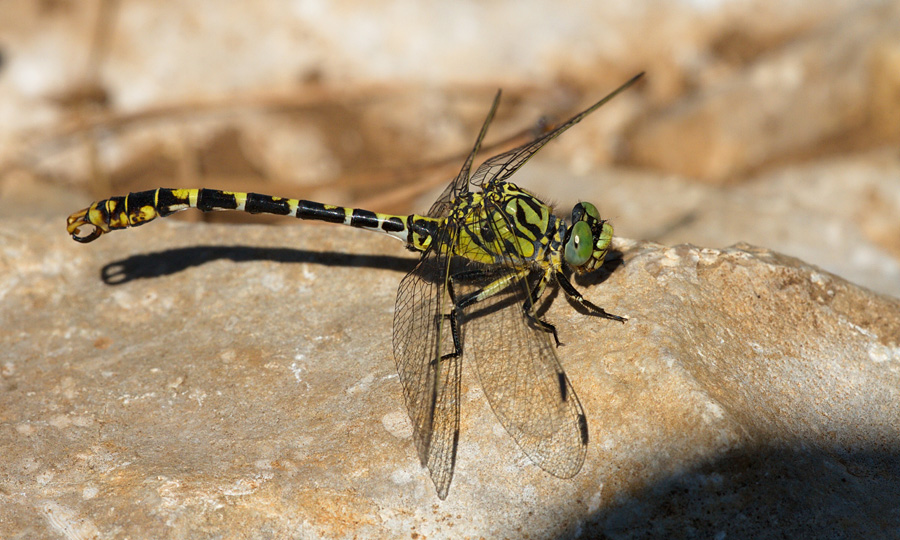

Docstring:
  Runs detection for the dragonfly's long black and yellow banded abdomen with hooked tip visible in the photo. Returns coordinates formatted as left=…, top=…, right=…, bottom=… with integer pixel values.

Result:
left=67, top=188, right=440, bottom=251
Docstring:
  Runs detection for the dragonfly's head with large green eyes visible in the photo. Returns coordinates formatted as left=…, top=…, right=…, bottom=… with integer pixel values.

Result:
left=563, top=203, right=613, bottom=274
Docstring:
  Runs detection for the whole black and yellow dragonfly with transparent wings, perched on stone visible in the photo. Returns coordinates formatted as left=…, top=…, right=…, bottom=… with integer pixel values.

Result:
left=67, top=73, right=643, bottom=500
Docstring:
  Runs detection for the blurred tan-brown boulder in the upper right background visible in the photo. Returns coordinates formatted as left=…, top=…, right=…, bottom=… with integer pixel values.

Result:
left=628, top=2, right=900, bottom=183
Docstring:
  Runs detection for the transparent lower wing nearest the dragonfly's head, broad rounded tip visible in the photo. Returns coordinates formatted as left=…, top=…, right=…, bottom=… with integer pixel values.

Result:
left=454, top=196, right=588, bottom=478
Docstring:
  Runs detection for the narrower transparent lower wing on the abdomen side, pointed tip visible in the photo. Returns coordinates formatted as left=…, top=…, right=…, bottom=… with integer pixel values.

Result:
left=394, top=225, right=462, bottom=499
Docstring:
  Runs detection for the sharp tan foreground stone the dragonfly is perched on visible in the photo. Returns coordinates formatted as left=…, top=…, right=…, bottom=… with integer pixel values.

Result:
left=0, top=219, right=900, bottom=539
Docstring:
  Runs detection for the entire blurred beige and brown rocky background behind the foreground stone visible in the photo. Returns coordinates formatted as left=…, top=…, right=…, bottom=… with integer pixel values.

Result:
left=0, top=0, right=900, bottom=296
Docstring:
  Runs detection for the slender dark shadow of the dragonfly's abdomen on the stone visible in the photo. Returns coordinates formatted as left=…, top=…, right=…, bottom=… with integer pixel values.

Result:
left=100, top=246, right=416, bottom=285
